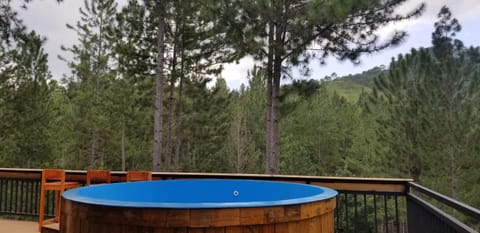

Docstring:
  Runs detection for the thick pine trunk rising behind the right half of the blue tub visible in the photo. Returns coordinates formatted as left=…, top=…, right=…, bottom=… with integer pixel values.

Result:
left=265, top=23, right=274, bottom=174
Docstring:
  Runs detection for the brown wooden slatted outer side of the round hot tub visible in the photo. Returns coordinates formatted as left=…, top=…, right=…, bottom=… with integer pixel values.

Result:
left=62, top=199, right=336, bottom=233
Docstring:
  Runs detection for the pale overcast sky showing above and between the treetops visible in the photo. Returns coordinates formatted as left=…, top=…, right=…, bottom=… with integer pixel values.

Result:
left=15, top=0, right=480, bottom=89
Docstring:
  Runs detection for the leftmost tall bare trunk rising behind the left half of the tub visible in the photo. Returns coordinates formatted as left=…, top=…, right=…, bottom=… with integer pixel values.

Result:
left=152, top=0, right=165, bottom=172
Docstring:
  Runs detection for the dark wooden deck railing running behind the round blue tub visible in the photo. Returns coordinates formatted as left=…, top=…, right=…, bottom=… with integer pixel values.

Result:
left=0, top=168, right=480, bottom=233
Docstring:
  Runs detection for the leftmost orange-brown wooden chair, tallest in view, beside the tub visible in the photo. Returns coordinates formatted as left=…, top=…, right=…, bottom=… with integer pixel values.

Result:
left=38, top=169, right=80, bottom=231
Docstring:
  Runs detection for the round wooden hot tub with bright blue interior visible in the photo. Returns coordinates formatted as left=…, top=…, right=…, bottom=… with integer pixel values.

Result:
left=60, top=180, right=337, bottom=233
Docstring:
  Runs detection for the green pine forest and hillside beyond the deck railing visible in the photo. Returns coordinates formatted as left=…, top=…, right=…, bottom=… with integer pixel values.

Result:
left=0, top=1, right=480, bottom=207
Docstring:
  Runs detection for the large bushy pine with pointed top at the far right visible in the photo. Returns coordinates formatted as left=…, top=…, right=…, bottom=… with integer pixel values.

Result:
left=374, top=7, right=479, bottom=192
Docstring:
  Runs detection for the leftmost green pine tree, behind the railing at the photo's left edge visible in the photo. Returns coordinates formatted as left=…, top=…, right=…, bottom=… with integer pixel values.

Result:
left=0, top=31, right=51, bottom=167
